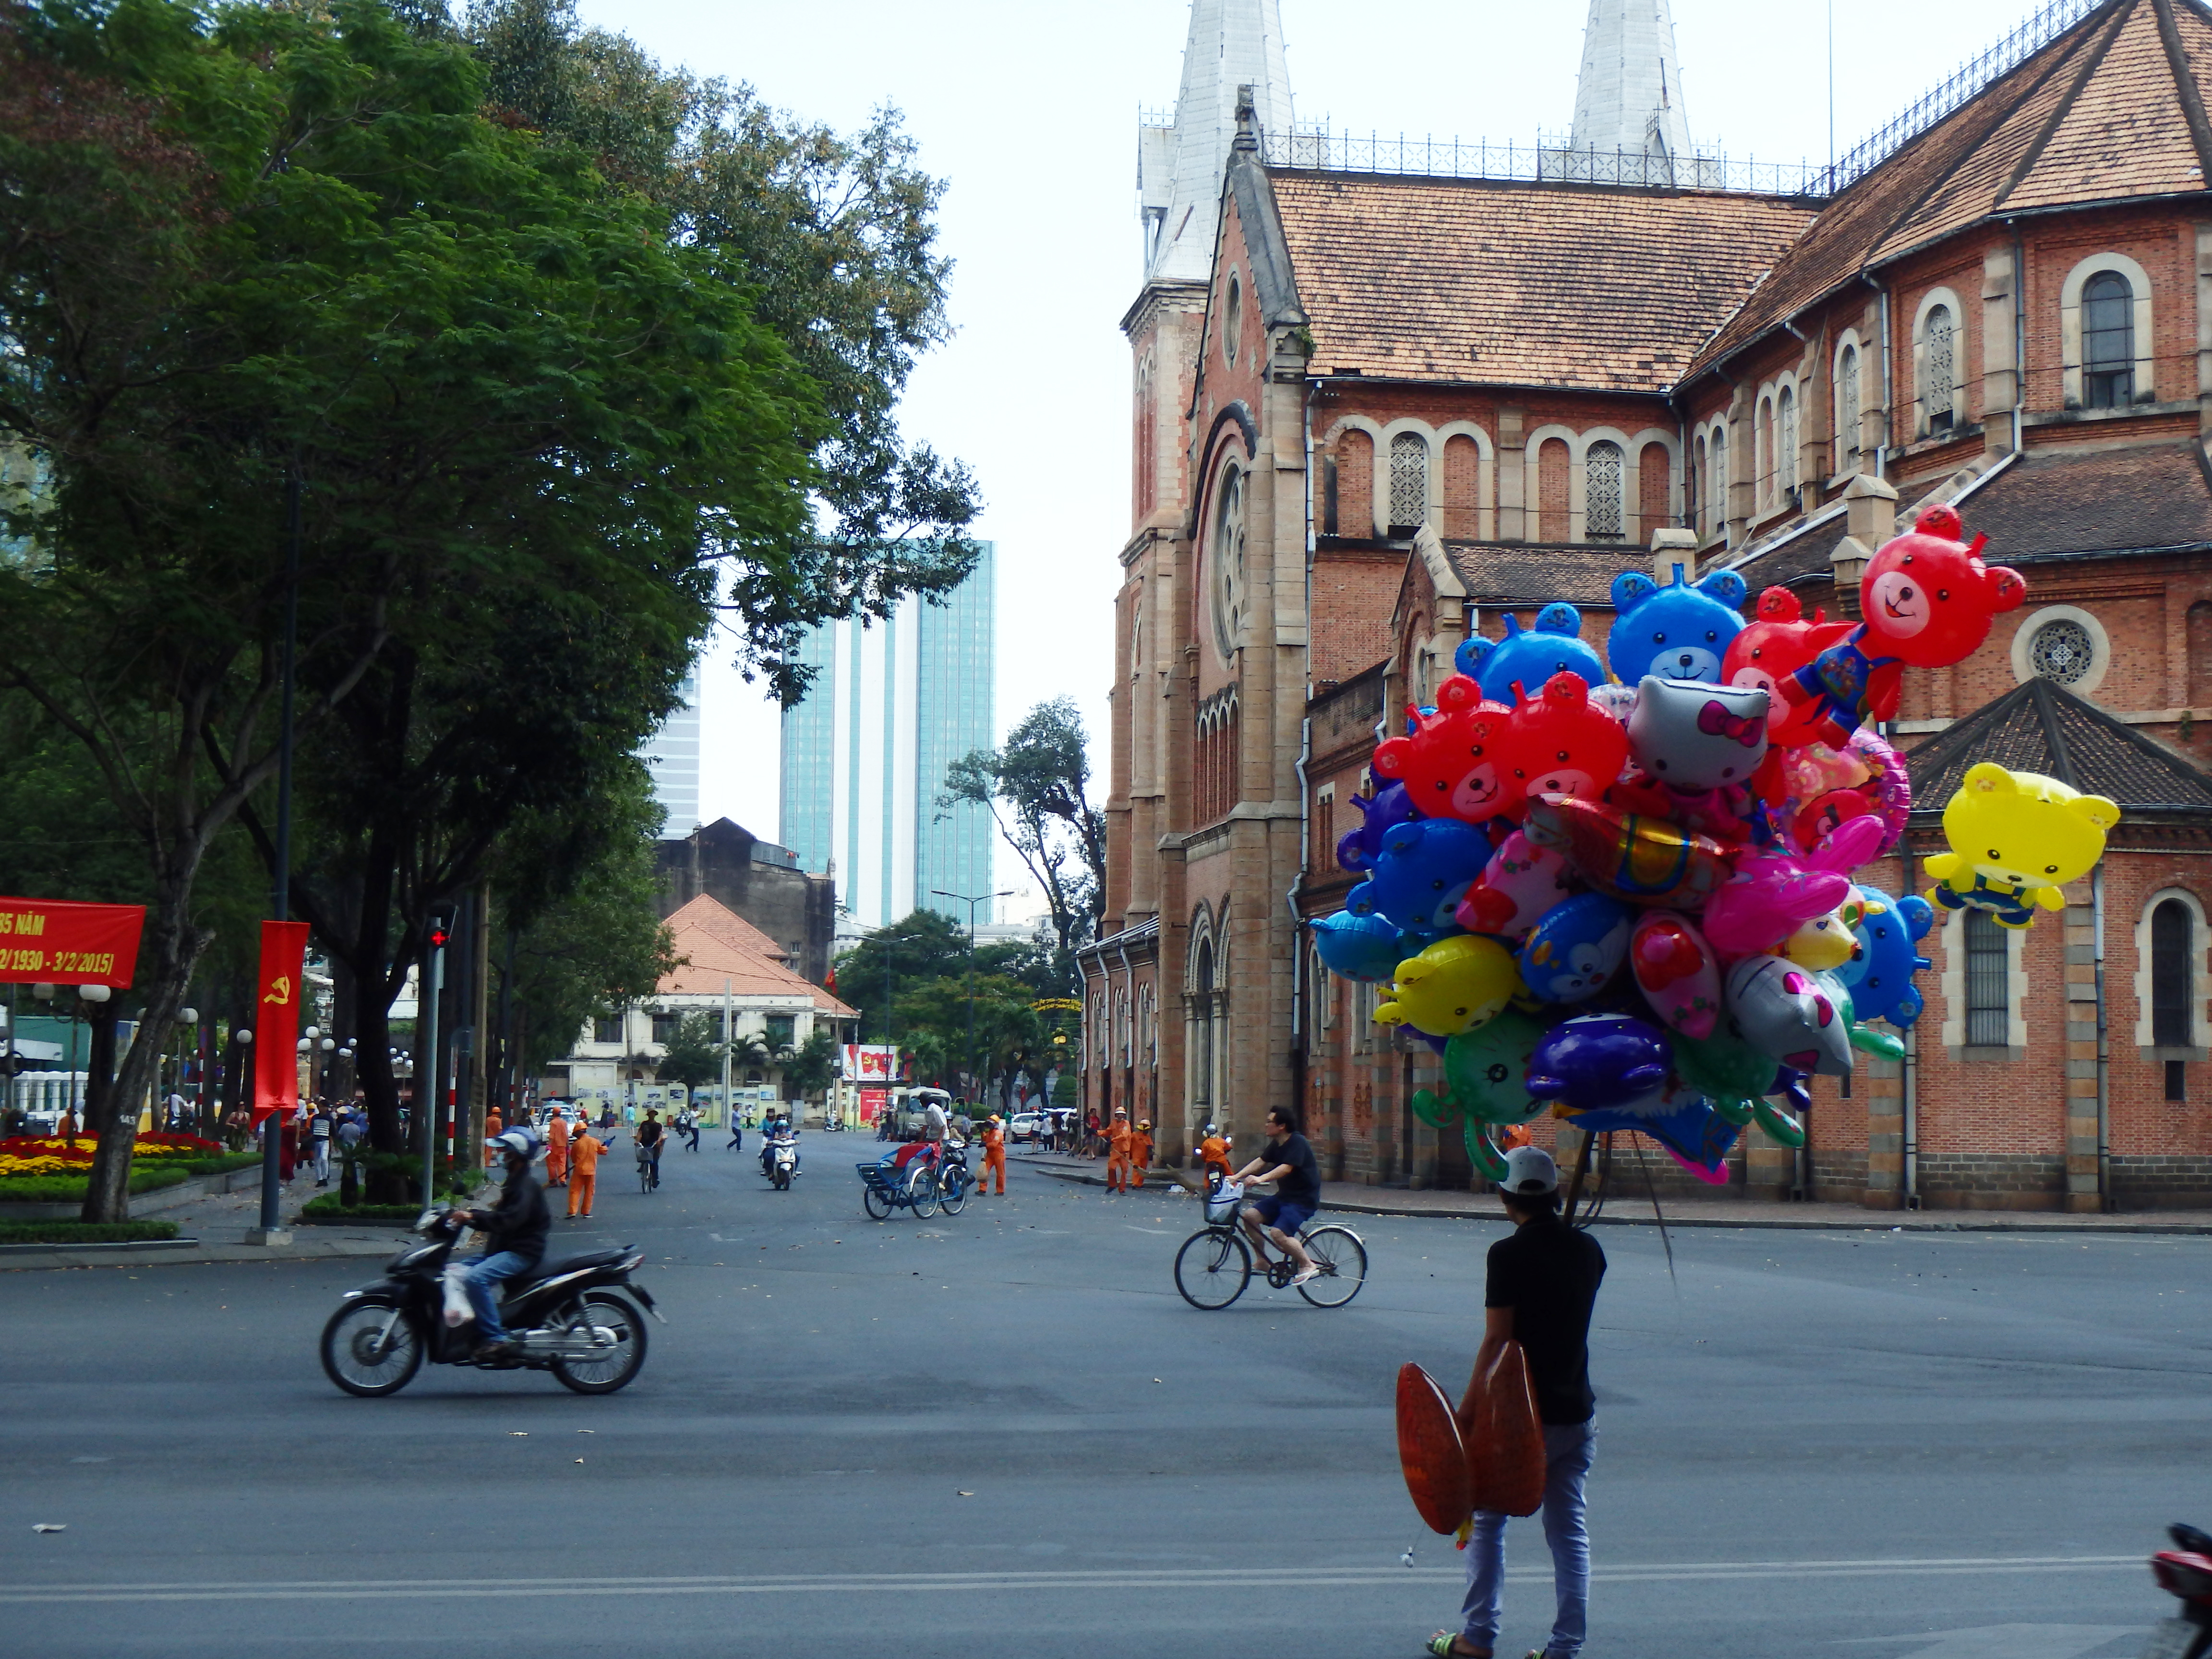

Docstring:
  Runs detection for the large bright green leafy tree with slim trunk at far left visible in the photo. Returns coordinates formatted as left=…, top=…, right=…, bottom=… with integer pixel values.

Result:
left=0, top=0, right=836, bottom=1221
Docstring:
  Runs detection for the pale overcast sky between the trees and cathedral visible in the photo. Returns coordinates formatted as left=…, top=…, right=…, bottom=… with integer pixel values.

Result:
left=582, top=0, right=2037, bottom=916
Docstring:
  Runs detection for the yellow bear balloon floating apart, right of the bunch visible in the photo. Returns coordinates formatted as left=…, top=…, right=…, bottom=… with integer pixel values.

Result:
left=1929, top=761, right=2119, bottom=927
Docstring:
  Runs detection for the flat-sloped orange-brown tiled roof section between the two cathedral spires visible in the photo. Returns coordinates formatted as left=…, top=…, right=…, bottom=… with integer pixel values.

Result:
left=1270, top=170, right=1812, bottom=394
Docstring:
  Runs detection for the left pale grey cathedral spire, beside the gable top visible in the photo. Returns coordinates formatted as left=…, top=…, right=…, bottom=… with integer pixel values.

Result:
left=1137, top=0, right=1289, bottom=283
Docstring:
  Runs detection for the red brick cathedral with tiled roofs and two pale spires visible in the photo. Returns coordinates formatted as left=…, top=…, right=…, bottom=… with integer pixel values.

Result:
left=1082, top=0, right=2212, bottom=1210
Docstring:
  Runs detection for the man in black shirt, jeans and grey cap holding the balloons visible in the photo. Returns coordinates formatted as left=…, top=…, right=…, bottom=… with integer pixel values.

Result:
left=1429, top=1146, right=1606, bottom=1659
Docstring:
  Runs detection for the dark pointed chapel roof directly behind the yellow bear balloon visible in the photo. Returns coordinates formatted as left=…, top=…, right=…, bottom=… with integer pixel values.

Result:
left=1904, top=677, right=2212, bottom=825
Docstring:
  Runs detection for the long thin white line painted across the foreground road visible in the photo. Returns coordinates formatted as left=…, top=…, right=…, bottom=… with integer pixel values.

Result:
left=0, top=1553, right=2143, bottom=1610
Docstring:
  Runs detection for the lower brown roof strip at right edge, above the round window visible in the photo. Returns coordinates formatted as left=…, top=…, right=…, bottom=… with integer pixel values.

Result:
left=1958, top=443, right=2212, bottom=564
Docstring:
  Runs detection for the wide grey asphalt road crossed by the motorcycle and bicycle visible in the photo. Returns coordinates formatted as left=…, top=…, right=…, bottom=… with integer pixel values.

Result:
left=0, top=1135, right=2212, bottom=1659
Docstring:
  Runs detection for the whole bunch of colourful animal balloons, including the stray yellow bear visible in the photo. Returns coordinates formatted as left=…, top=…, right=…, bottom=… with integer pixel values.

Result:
left=1314, top=506, right=2119, bottom=1183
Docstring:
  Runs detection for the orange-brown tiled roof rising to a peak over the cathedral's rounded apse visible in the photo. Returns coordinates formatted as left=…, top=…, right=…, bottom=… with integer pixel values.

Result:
left=1692, top=0, right=2212, bottom=372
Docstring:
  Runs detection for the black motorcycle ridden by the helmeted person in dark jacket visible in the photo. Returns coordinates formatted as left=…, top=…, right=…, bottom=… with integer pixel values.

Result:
left=323, top=1205, right=668, bottom=1398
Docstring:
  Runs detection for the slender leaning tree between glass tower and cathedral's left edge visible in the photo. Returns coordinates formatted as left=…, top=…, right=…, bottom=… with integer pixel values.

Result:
left=938, top=697, right=1106, bottom=996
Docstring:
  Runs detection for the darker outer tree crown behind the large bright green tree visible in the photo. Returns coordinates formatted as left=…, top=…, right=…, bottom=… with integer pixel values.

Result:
left=460, top=0, right=980, bottom=701
